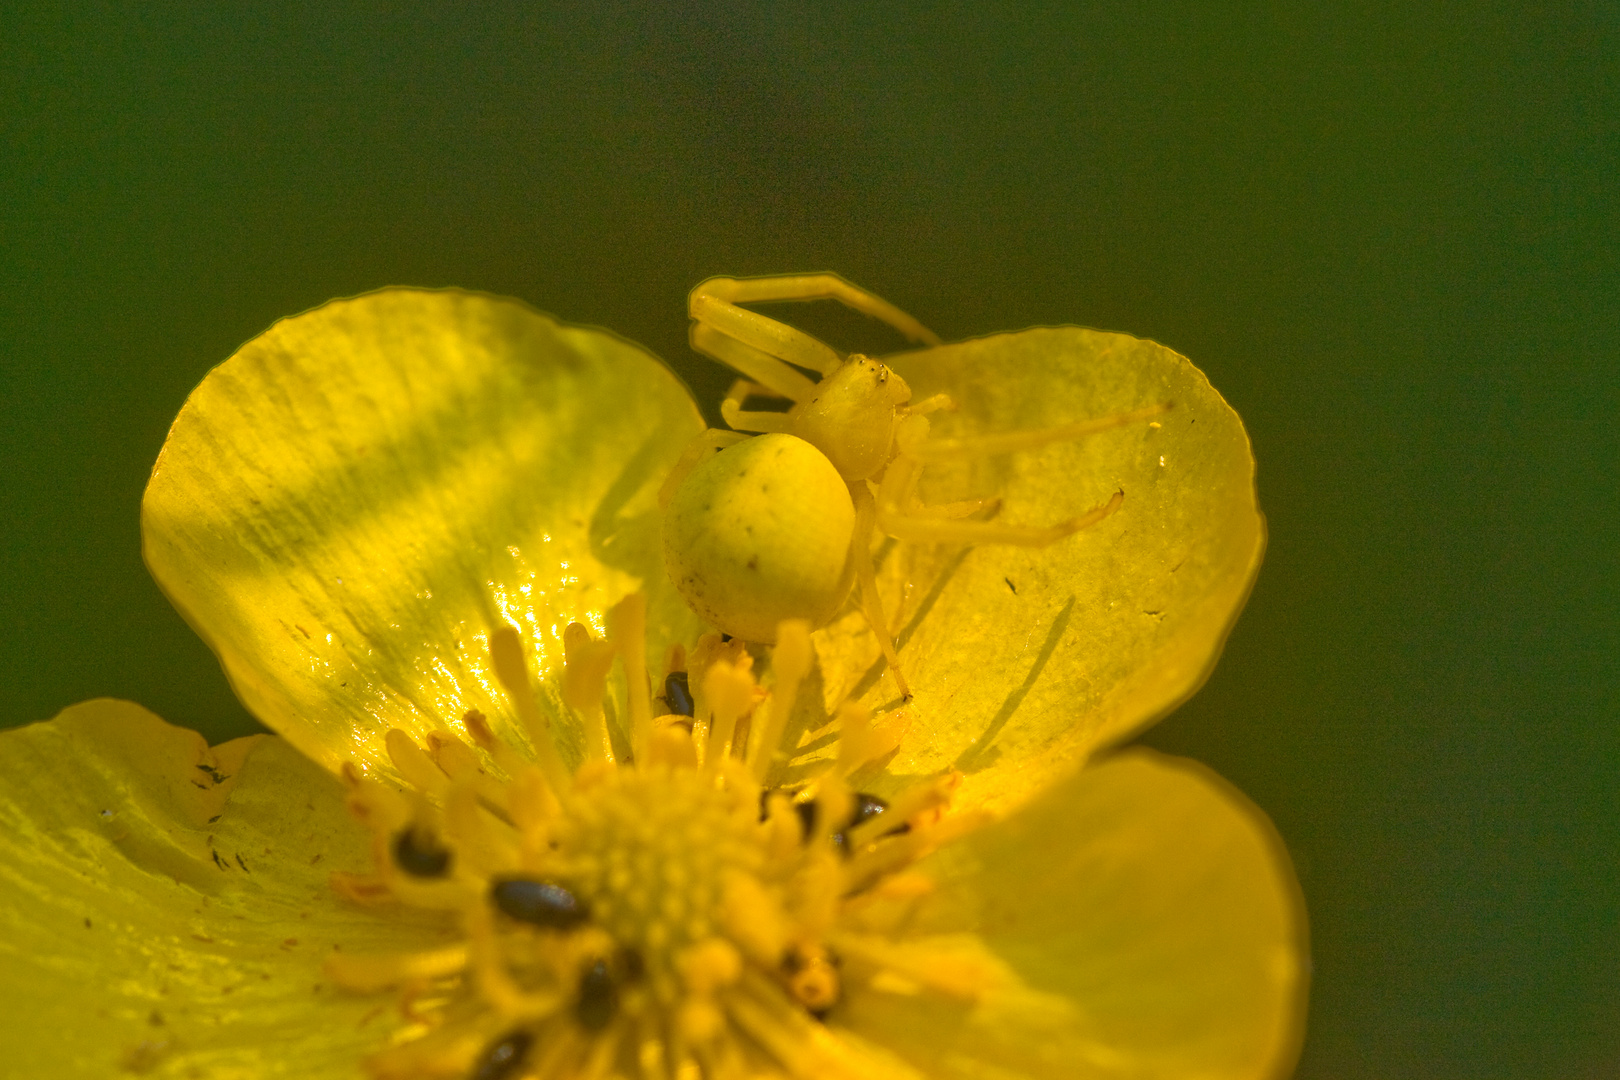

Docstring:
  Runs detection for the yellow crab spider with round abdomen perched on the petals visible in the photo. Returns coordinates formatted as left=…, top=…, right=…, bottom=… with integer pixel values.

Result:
left=661, top=274, right=1170, bottom=698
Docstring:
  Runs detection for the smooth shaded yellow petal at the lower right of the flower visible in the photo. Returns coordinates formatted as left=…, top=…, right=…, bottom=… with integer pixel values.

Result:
left=841, top=750, right=1307, bottom=1080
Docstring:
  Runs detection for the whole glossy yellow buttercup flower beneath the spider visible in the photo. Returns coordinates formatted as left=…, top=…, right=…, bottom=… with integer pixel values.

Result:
left=0, top=290, right=1306, bottom=1080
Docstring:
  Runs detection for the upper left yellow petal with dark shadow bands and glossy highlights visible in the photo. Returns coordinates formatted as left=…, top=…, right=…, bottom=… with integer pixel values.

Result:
left=141, top=290, right=701, bottom=772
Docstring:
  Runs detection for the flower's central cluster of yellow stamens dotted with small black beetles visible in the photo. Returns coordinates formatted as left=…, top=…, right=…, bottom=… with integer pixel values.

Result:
left=327, top=596, right=964, bottom=1080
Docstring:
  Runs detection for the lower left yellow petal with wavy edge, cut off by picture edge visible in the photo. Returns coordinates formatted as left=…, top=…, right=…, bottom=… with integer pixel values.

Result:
left=0, top=699, right=454, bottom=1080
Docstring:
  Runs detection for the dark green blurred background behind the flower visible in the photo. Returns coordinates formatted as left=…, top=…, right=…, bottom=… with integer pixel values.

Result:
left=0, top=0, right=1620, bottom=1080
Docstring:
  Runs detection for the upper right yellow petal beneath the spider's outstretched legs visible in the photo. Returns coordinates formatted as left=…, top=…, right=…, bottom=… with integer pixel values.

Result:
left=820, top=327, right=1265, bottom=808
